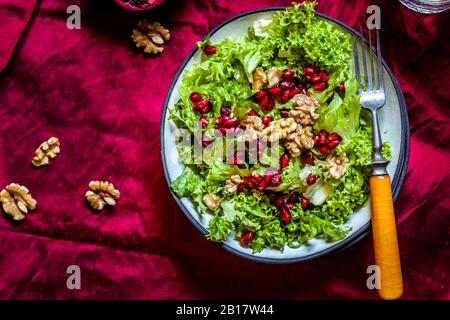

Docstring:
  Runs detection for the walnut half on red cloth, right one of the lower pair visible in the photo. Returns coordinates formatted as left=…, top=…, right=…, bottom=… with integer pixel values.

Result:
left=86, top=181, right=120, bottom=210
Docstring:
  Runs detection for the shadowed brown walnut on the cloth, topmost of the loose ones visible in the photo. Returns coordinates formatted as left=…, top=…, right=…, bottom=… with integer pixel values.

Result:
left=131, top=20, right=170, bottom=54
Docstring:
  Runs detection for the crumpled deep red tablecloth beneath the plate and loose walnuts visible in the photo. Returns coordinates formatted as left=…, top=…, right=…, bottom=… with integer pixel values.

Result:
left=0, top=0, right=450, bottom=299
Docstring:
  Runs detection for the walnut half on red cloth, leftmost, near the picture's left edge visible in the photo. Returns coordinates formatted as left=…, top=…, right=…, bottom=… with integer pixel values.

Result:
left=0, top=183, right=37, bottom=221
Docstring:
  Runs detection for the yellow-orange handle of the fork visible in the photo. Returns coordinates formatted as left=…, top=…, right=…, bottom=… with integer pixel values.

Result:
left=370, top=175, right=403, bottom=300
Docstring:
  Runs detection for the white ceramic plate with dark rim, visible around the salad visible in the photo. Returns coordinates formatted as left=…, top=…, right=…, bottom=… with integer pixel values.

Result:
left=161, top=7, right=409, bottom=263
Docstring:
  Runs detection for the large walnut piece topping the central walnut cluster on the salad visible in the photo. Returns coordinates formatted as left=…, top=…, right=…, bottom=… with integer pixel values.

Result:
left=289, top=93, right=320, bottom=126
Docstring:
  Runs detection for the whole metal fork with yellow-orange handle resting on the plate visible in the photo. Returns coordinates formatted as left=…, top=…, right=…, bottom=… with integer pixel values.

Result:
left=353, top=29, right=403, bottom=300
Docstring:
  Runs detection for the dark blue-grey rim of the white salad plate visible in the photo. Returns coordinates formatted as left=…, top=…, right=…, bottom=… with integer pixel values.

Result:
left=160, top=6, right=410, bottom=264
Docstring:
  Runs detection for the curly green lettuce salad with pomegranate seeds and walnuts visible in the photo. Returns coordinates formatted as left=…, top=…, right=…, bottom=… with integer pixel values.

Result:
left=170, top=2, right=390, bottom=252
